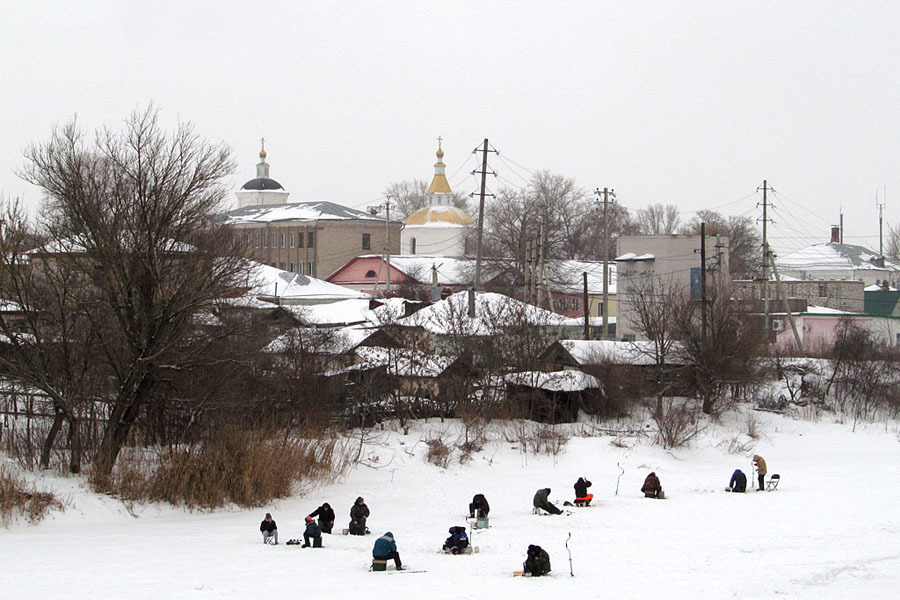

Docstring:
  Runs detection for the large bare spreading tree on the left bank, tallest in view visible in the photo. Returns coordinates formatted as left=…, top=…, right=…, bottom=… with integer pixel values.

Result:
left=21, top=107, right=248, bottom=476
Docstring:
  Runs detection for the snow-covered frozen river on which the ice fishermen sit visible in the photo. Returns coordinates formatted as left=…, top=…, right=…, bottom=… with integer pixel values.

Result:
left=0, top=406, right=900, bottom=600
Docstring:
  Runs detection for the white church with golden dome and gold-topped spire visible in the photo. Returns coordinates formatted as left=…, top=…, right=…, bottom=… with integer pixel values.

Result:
left=400, top=138, right=475, bottom=256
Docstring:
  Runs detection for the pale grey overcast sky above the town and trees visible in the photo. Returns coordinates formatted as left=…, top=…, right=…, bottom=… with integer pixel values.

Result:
left=0, top=0, right=900, bottom=253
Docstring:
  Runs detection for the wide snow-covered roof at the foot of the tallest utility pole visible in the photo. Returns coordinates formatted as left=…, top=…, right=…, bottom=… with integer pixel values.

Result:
left=398, top=292, right=566, bottom=335
